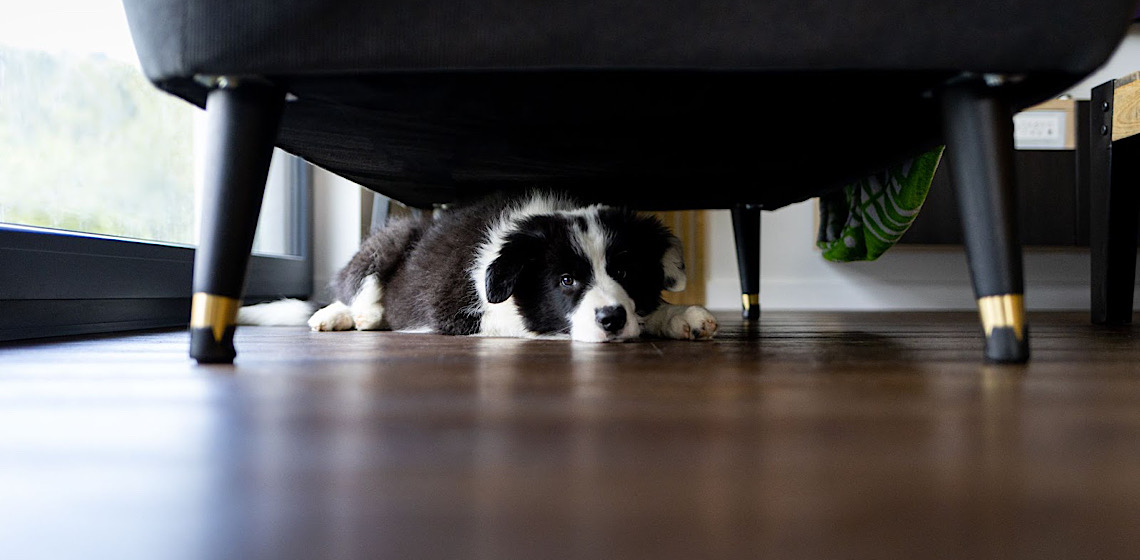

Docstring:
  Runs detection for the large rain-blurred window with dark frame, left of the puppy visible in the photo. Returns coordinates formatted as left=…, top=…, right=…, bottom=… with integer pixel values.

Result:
left=0, top=0, right=312, bottom=340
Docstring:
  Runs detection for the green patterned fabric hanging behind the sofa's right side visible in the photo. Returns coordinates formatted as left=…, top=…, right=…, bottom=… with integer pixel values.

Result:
left=816, top=147, right=943, bottom=262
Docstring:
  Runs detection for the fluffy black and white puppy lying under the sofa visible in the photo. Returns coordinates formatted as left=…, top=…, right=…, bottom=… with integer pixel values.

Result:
left=249, top=192, right=717, bottom=342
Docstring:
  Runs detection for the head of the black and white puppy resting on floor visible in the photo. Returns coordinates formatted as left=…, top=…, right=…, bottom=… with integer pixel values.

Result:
left=486, top=206, right=685, bottom=342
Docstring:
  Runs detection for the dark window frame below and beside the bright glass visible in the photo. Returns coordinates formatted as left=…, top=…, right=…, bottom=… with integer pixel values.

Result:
left=0, top=156, right=312, bottom=341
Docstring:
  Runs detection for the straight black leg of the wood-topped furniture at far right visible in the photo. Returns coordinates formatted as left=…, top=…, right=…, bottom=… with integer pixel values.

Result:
left=1089, top=80, right=1140, bottom=325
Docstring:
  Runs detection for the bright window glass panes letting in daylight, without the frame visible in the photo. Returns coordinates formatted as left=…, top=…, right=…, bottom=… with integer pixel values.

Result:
left=0, top=0, right=296, bottom=254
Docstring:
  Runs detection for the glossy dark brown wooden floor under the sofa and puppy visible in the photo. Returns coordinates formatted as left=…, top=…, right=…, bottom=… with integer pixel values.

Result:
left=0, top=313, right=1140, bottom=560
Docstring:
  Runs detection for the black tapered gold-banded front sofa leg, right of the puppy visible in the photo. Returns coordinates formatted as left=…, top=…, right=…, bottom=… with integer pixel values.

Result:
left=942, top=83, right=1029, bottom=363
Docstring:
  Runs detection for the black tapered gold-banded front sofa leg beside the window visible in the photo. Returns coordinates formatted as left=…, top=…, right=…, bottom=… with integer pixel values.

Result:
left=190, top=79, right=285, bottom=364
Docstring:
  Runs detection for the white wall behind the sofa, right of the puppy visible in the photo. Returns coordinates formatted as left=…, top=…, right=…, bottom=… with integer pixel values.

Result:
left=706, top=25, right=1140, bottom=310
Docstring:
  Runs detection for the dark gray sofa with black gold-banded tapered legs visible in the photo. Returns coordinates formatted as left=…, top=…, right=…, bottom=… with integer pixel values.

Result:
left=124, top=0, right=1134, bottom=362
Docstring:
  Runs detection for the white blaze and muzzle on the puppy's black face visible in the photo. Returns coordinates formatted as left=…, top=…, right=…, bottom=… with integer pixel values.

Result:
left=570, top=208, right=641, bottom=342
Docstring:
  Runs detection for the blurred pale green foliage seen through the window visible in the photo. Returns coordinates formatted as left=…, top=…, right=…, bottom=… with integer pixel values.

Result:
left=0, top=44, right=194, bottom=244
